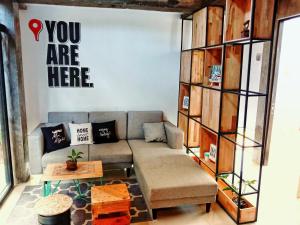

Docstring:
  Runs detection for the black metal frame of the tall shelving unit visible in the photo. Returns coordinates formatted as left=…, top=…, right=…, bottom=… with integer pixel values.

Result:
left=178, top=0, right=278, bottom=224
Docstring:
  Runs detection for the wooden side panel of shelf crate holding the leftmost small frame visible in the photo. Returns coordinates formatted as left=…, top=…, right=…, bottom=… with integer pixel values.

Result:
left=190, top=85, right=202, bottom=117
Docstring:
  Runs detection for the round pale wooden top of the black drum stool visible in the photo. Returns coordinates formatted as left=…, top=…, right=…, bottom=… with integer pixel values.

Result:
left=34, top=194, right=73, bottom=216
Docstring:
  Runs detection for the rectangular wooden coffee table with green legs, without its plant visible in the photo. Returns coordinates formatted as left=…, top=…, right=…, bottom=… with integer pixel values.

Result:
left=41, top=161, right=103, bottom=198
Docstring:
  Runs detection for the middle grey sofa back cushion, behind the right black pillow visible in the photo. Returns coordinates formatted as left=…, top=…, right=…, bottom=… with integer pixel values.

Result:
left=89, top=111, right=127, bottom=139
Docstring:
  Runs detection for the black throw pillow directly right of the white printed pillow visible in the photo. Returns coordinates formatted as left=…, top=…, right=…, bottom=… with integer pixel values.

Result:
left=92, top=120, right=118, bottom=144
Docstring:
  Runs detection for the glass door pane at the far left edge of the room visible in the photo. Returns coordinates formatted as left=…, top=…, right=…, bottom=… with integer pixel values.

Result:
left=0, top=24, right=13, bottom=204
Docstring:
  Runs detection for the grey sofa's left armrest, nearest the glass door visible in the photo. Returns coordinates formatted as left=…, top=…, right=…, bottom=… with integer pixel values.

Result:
left=28, top=124, right=44, bottom=174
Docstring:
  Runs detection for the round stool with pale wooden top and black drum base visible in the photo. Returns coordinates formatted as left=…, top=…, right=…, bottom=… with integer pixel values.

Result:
left=34, top=194, right=73, bottom=225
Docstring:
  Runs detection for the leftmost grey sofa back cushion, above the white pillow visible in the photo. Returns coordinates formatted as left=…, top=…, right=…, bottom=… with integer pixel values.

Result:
left=48, top=112, right=89, bottom=123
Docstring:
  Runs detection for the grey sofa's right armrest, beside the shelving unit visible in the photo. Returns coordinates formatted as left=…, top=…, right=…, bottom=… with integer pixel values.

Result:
left=164, top=122, right=183, bottom=149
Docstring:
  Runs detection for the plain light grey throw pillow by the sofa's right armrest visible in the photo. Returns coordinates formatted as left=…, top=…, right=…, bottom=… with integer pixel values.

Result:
left=143, top=122, right=167, bottom=142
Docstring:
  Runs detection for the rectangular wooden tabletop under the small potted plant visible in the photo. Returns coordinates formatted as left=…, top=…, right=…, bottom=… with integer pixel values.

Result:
left=41, top=161, right=103, bottom=181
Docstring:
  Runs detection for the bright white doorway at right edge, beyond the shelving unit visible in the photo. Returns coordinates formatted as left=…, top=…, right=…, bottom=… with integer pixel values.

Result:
left=259, top=17, right=300, bottom=225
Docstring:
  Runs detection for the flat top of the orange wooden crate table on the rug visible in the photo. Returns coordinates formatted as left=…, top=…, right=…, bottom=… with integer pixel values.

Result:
left=91, top=184, right=130, bottom=204
